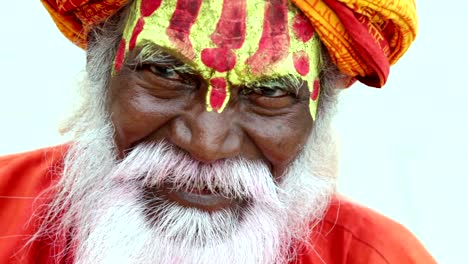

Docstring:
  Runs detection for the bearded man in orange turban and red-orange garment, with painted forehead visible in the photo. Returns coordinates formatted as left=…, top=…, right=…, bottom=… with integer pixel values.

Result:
left=0, top=0, right=435, bottom=263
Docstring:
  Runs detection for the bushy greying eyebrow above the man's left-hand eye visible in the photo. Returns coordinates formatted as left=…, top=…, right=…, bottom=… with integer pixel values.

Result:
left=125, top=42, right=197, bottom=74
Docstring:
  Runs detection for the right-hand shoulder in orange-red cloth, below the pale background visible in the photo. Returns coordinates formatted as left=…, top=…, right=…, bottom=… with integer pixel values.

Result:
left=298, top=197, right=436, bottom=264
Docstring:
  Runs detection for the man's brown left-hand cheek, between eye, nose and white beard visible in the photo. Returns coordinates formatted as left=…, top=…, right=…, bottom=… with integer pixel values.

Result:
left=111, top=87, right=183, bottom=153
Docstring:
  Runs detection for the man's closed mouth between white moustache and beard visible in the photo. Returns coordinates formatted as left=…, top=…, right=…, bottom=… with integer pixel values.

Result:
left=145, top=185, right=242, bottom=212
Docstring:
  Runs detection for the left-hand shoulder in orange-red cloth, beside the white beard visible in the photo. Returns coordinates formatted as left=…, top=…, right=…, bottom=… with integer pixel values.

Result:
left=0, top=145, right=67, bottom=263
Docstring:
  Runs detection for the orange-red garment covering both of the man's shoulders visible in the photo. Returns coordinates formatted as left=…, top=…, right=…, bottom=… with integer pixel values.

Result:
left=0, top=146, right=436, bottom=264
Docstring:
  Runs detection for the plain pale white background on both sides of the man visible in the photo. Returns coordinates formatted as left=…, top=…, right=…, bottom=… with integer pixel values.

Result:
left=0, top=0, right=468, bottom=263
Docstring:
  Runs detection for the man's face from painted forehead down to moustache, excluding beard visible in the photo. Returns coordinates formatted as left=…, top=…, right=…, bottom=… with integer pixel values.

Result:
left=110, top=0, right=318, bottom=206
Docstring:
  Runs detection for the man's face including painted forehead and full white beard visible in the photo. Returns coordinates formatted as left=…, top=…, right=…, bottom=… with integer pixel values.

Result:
left=50, top=0, right=333, bottom=263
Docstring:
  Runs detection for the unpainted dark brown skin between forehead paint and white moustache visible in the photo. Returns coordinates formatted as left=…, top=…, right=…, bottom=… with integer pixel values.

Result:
left=110, top=47, right=313, bottom=179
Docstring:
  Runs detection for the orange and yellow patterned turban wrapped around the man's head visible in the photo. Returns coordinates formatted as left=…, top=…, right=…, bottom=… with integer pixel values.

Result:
left=41, top=0, right=417, bottom=87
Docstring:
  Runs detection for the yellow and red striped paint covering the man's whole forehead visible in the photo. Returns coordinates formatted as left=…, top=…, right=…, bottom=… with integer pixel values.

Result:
left=114, top=0, right=320, bottom=118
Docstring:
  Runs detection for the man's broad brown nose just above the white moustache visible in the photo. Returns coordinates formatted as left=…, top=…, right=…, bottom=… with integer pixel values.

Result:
left=170, top=111, right=242, bottom=163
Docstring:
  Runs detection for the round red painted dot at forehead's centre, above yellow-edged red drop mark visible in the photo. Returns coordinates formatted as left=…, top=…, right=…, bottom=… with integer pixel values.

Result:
left=201, top=48, right=236, bottom=72
